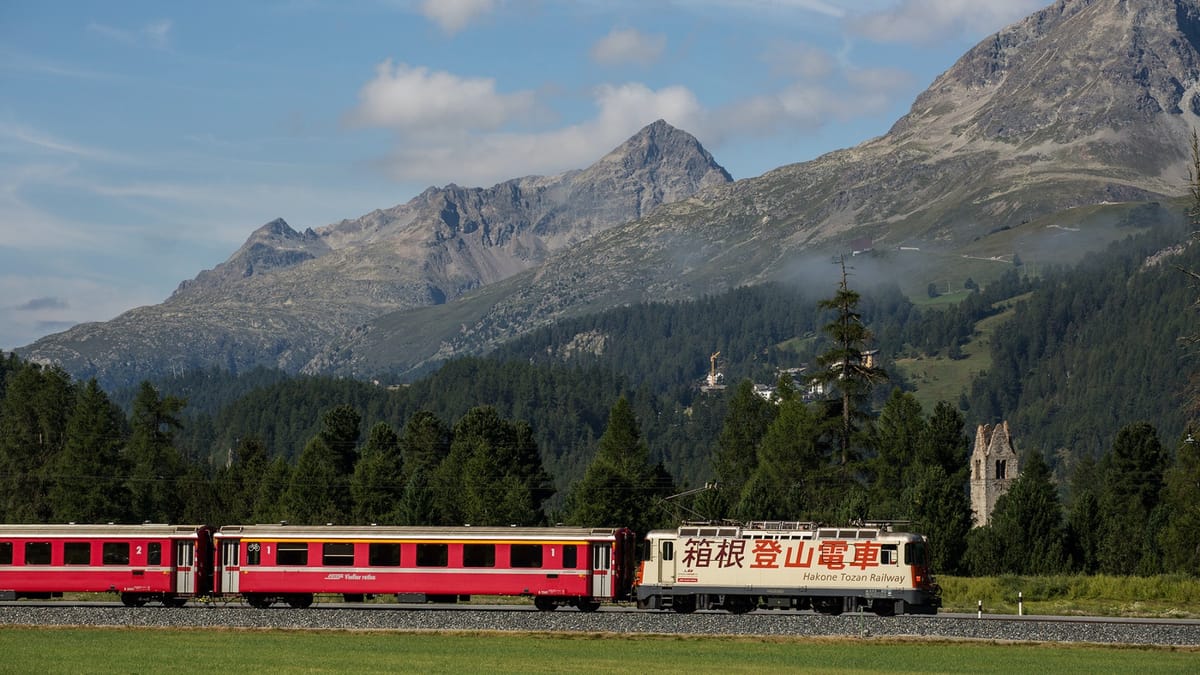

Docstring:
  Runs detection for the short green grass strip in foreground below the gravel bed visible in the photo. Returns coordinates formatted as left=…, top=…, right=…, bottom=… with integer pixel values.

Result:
left=0, top=627, right=1200, bottom=674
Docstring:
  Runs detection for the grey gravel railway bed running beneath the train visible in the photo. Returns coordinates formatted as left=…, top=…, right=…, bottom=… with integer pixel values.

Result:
left=0, top=601, right=1200, bottom=649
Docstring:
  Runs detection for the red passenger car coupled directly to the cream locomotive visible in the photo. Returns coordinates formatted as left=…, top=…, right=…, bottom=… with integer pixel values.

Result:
left=214, top=525, right=635, bottom=611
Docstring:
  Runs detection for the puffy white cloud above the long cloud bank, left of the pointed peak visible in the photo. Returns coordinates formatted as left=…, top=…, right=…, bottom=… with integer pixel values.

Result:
left=349, top=59, right=535, bottom=135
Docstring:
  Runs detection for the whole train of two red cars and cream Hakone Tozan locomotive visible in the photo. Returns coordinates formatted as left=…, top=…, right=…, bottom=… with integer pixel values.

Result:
left=0, top=521, right=941, bottom=616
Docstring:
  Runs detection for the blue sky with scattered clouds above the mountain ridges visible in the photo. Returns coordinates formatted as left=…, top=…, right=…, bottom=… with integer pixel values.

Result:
left=0, top=0, right=1049, bottom=350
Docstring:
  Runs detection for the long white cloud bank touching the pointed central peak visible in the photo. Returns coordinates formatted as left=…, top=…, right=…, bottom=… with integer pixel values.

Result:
left=369, top=83, right=704, bottom=186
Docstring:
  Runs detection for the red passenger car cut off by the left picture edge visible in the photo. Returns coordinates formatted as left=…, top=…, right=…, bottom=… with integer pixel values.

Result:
left=0, top=525, right=212, bottom=607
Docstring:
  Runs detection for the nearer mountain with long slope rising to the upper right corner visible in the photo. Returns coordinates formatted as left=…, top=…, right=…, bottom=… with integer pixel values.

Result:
left=310, top=0, right=1200, bottom=375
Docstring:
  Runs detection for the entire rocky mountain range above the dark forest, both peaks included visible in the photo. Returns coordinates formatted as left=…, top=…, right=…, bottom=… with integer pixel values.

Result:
left=18, top=0, right=1200, bottom=381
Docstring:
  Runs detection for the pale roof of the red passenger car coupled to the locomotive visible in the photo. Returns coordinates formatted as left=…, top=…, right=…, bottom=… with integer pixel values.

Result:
left=216, top=524, right=620, bottom=540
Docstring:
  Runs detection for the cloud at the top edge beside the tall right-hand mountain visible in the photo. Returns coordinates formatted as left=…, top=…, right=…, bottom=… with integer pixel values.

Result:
left=847, top=0, right=1045, bottom=44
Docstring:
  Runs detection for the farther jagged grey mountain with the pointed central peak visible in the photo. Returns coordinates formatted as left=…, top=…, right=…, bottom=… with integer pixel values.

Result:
left=17, top=120, right=732, bottom=386
